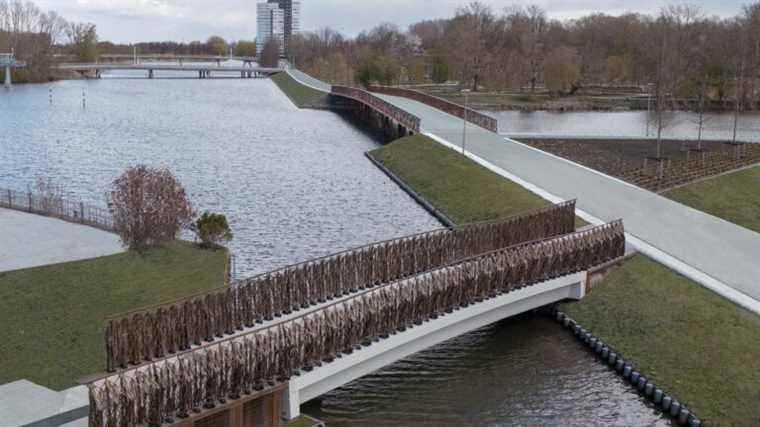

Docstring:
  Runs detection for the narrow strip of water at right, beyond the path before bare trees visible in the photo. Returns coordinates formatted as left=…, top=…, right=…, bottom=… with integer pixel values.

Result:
left=492, top=111, right=760, bottom=142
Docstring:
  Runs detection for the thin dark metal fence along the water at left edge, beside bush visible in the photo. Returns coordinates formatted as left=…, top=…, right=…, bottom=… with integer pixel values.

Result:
left=0, top=189, right=114, bottom=231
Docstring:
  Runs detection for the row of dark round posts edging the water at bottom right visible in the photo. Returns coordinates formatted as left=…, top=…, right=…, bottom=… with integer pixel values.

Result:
left=550, top=307, right=706, bottom=427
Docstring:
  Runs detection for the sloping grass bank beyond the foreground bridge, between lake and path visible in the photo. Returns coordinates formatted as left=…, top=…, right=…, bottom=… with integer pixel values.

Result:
left=371, top=135, right=549, bottom=224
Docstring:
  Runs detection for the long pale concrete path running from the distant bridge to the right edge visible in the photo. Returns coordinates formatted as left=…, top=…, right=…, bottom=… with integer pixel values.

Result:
left=378, top=95, right=760, bottom=312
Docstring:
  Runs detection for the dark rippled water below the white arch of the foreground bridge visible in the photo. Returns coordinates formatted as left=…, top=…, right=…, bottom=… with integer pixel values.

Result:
left=302, top=316, right=669, bottom=426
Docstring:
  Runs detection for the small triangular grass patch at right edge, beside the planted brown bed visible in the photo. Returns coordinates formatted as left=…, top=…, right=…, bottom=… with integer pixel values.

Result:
left=663, top=166, right=760, bottom=233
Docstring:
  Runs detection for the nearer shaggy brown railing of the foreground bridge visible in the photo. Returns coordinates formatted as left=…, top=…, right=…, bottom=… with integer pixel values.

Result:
left=89, top=222, right=625, bottom=427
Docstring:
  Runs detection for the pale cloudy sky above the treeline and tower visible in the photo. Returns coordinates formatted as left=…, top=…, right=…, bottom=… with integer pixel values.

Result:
left=36, top=0, right=750, bottom=43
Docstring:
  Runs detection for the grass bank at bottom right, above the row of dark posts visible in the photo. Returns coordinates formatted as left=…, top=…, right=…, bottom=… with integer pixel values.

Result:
left=562, top=255, right=760, bottom=425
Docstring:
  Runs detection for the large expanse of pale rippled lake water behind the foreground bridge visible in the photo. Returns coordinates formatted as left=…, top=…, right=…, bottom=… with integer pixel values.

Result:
left=0, top=71, right=440, bottom=277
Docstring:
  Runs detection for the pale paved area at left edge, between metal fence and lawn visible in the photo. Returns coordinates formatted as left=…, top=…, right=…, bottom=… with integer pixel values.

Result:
left=0, top=209, right=124, bottom=272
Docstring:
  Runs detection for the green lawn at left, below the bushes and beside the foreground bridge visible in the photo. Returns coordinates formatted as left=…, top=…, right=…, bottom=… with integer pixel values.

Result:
left=0, top=243, right=227, bottom=390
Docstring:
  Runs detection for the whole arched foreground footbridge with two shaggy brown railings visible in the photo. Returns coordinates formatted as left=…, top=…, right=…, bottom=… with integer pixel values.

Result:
left=89, top=202, right=625, bottom=426
